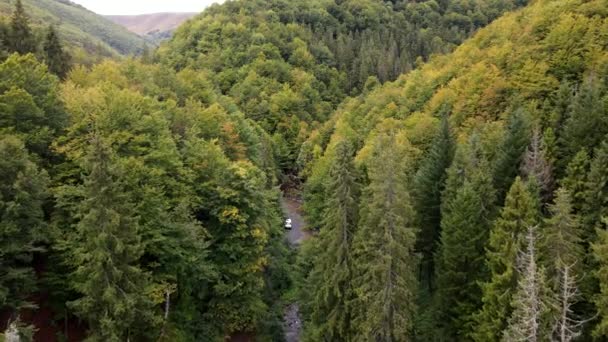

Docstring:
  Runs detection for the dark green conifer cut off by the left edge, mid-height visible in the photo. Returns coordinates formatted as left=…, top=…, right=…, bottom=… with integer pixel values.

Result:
left=0, top=135, right=49, bottom=311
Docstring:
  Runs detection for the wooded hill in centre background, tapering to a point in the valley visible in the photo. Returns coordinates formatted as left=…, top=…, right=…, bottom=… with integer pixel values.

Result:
left=158, top=0, right=524, bottom=172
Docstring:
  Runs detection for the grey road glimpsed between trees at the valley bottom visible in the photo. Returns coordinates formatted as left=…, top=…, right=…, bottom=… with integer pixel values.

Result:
left=281, top=196, right=311, bottom=342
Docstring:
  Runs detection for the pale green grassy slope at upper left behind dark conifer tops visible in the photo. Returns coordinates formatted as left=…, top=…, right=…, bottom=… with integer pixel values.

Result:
left=0, top=0, right=145, bottom=56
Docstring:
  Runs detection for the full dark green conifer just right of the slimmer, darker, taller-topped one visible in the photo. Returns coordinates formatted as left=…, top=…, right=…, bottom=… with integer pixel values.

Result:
left=434, top=139, right=495, bottom=340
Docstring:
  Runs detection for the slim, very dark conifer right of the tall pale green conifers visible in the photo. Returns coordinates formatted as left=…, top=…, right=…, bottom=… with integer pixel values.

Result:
left=412, top=115, right=454, bottom=290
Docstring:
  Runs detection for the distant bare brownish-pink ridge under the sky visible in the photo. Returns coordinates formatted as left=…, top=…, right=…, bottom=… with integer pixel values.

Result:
left=105, top=12, right=197, bottom=41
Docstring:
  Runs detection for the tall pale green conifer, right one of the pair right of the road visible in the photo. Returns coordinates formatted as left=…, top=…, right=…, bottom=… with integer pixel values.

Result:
left=352, top=127, right=417, bottom=341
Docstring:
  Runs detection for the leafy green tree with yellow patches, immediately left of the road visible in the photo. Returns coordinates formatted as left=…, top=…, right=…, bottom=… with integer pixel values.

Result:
left=184, top=138, right=276, bottom=339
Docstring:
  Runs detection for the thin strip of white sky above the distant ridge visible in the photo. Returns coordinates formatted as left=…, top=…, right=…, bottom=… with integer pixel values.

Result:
left=71, top=0, right=223, bottom=14
